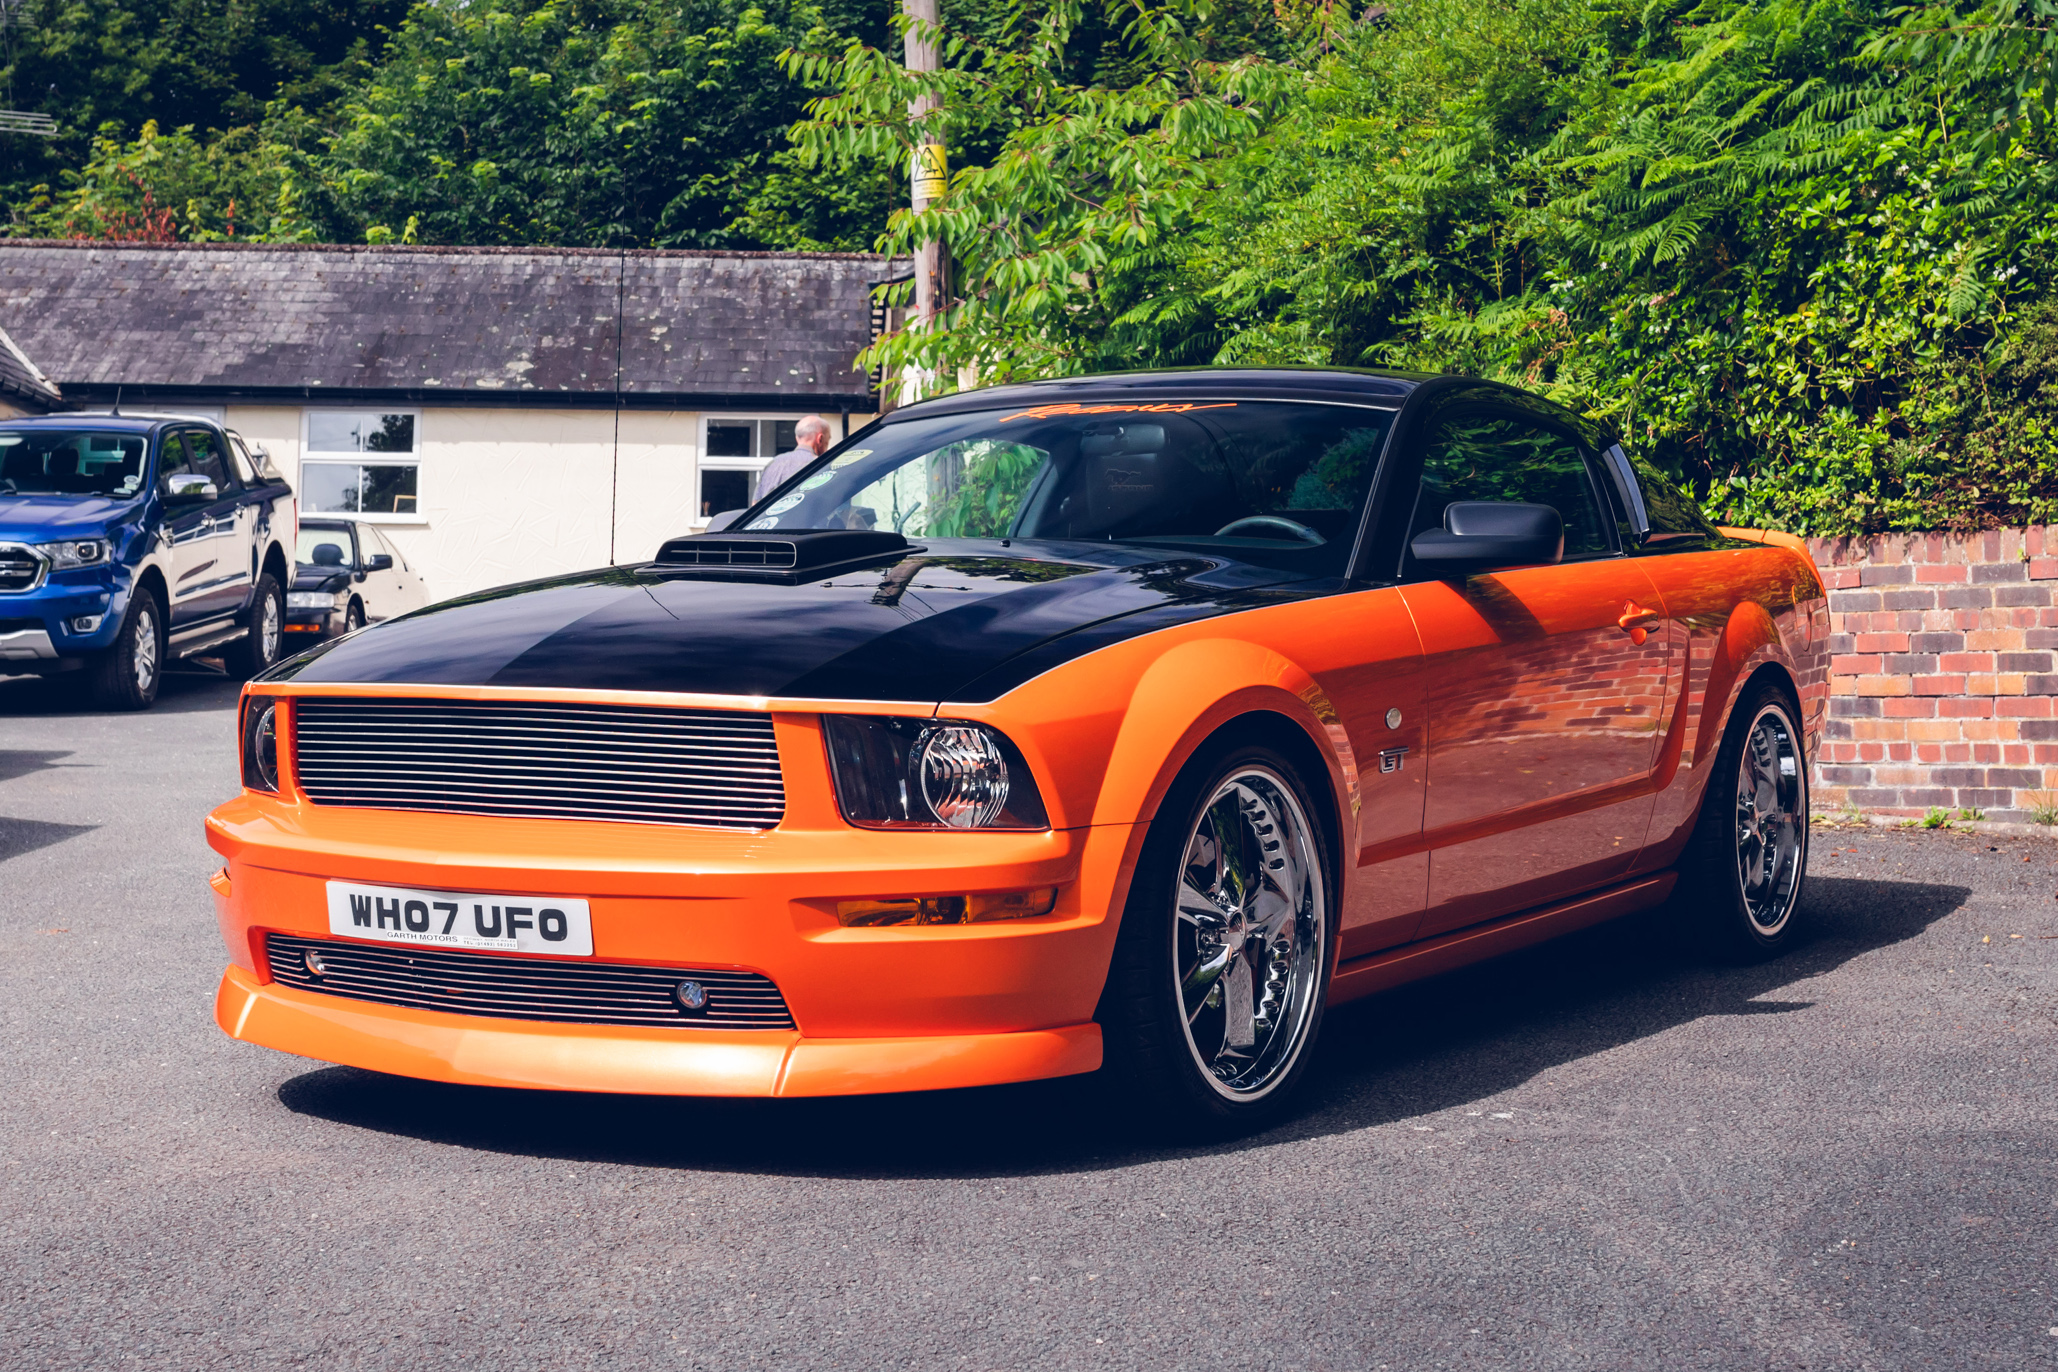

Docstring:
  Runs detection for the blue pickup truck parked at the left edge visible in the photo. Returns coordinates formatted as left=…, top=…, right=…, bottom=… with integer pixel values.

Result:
left=0, top=413, right=298, bottom=710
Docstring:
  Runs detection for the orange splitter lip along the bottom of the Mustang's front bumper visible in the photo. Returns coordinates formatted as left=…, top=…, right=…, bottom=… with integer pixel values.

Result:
left=214, top=967, right=1101, bottom=1096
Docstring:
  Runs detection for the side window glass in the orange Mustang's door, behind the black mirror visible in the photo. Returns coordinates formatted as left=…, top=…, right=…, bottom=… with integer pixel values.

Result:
left=1410, top=416, right=1609, bottom=557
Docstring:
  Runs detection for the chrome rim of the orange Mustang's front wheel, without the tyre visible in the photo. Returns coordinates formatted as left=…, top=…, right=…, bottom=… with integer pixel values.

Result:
left=1173, top=767, right=1327, bottom=1100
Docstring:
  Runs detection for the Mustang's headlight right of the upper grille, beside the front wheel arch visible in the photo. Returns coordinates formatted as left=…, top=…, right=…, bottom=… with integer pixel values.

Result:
left=823, top=714, right=1050, bottom=829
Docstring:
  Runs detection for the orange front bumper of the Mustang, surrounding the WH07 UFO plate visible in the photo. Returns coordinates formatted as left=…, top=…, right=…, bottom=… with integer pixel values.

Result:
left=208, top=761, right=1140, bottom=1096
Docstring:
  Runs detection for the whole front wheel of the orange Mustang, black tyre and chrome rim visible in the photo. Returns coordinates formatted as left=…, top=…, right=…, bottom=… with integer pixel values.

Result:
left=1097, top=745, right=1338, bottom=1135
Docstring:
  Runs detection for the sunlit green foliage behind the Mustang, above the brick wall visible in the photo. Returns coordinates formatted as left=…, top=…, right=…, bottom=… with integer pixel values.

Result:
left=796, top=0, right=2058, bottom=533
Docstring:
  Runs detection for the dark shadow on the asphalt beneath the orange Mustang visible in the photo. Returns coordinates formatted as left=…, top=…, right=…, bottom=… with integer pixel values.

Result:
left=278, top=876, right=1972, bottom=1179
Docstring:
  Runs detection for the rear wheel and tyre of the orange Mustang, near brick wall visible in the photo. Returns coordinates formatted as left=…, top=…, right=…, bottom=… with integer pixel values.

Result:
left=1677, top=677, right=1809, bottom=963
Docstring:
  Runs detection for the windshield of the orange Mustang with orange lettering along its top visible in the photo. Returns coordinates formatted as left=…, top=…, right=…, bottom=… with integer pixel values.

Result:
left=743, top=401, right=1393, bottom=574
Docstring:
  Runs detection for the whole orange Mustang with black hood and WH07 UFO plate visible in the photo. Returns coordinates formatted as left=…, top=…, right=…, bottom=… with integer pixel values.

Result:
left=208, top=370, right=1828, bottom=1129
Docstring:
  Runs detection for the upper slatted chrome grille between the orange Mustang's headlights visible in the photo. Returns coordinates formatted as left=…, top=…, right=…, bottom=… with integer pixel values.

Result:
left=292, top=697, right=786, bottom=829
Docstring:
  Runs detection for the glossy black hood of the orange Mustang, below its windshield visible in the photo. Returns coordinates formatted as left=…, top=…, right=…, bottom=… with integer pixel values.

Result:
left=265, top=539, right=1344, bottom=701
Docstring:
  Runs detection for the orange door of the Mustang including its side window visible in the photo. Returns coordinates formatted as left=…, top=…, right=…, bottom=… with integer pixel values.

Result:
left=1401, top=407, right=1669, bottom=938
